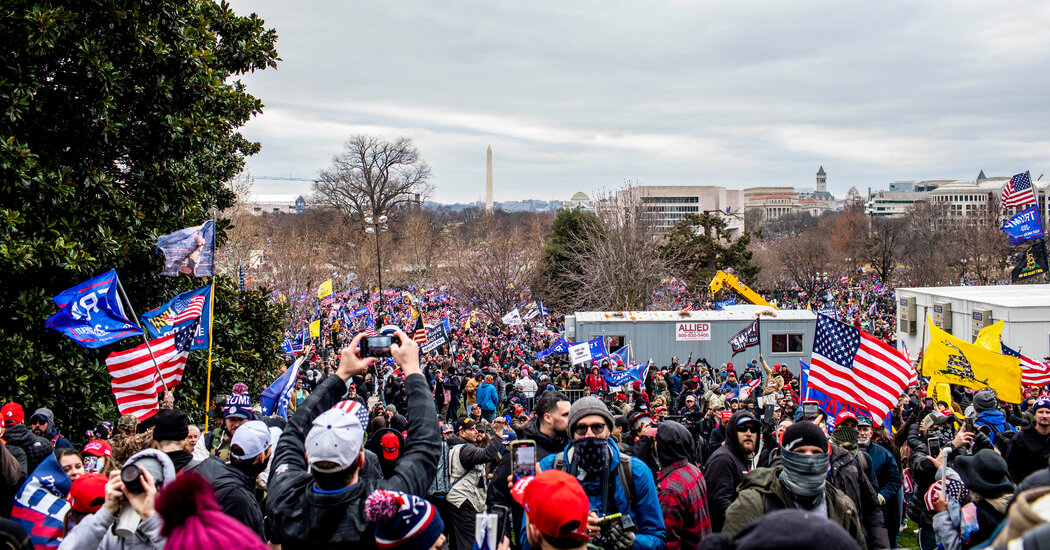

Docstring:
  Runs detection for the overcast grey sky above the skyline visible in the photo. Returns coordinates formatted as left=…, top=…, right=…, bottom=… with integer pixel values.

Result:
left=231, top=0, right=1050, bottom=203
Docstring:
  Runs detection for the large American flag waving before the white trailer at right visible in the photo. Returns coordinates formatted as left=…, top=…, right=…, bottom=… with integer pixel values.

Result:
left=810, top=315, right=915, bottom=426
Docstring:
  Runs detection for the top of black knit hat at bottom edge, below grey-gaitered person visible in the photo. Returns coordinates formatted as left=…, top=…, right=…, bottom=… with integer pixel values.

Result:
left=700, top=510, right=860, bottom=550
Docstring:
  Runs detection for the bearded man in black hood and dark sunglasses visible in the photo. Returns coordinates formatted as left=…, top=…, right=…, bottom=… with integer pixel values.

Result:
left=707, top=410, right=762, bottom=532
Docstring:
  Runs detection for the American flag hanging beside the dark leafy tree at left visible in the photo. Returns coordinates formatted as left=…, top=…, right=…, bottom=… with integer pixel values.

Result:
left=106, top=322, right=197, bottom=420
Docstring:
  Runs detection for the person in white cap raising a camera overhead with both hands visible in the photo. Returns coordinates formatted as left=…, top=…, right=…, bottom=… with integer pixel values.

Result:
left=266, top=330, right=441, bottom=550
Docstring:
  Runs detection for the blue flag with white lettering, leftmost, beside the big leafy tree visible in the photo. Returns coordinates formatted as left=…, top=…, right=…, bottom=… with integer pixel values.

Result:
left=46, top=270, right=142, bottom=348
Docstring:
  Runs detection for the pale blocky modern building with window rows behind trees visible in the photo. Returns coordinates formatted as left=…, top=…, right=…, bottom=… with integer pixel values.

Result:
left=616, top=185, right=743, bottom=237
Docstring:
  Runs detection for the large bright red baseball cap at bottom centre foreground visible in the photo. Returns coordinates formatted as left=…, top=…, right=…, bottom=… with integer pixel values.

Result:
left=510, top=470, right=590, bottom=543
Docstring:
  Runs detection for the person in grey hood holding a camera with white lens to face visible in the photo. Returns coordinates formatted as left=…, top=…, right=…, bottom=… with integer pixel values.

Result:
left=59, top=449, right=175, bottom=550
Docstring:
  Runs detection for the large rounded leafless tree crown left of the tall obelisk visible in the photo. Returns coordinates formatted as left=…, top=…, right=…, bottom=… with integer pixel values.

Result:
left=313, top=135, right=433, bottom=218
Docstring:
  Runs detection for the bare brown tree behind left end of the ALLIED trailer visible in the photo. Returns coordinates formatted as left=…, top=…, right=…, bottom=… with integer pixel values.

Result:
left=568, top=188, right=670, bottom=311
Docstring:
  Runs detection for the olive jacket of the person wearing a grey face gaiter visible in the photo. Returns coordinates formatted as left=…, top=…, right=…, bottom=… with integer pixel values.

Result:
left=722, top=466, right=867, bottom=550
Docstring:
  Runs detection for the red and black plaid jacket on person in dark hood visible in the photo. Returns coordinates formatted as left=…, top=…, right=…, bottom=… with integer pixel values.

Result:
left=656, top=460, right=711, bottom=550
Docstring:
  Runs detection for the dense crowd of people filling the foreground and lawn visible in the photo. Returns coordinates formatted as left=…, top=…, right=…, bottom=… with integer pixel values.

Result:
left=6, top=279, right=1050, bottom=550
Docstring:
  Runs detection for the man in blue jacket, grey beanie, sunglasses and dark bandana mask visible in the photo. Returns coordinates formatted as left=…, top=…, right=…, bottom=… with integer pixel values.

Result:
left=540, top=397, right=666, bottom=550
